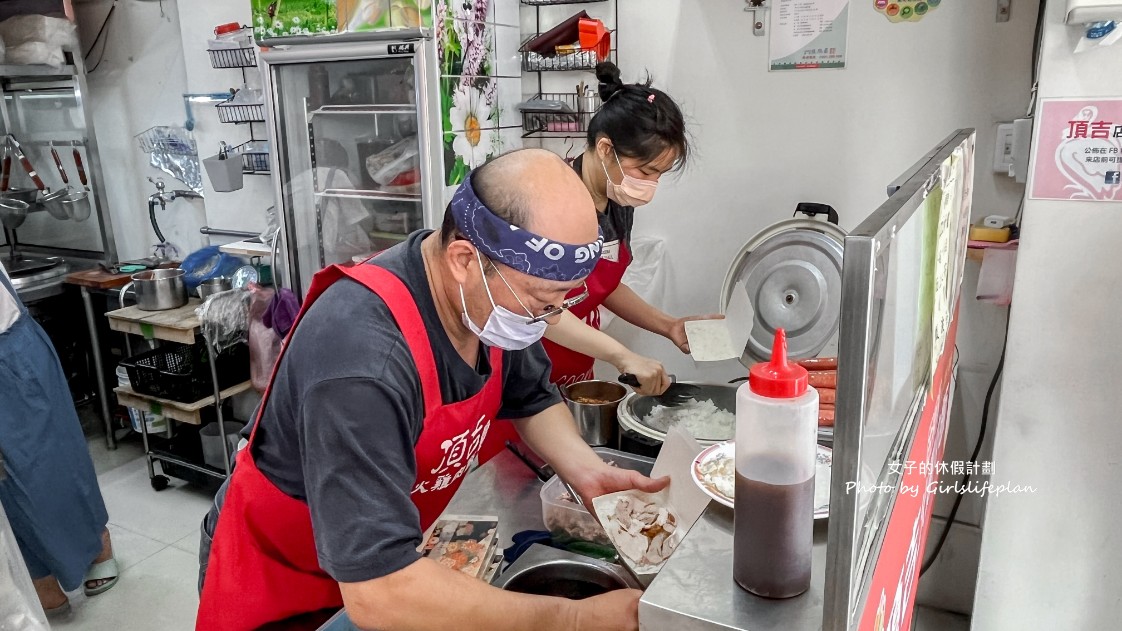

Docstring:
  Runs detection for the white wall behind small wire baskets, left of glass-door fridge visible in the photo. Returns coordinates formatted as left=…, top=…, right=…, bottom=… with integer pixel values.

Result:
left=76, top=0, right=273, bottom=259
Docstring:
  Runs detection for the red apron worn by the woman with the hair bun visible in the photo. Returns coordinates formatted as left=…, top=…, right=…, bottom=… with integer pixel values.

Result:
left=542, top=239, right=632, bottom=385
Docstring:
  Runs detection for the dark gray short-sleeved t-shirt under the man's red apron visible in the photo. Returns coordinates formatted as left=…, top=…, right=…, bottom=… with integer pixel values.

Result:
left=252, top=231, right=561, bottom=583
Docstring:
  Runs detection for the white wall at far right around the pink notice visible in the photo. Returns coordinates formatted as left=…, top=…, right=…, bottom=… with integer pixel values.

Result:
left=973, top=0, right=1122, bottom=631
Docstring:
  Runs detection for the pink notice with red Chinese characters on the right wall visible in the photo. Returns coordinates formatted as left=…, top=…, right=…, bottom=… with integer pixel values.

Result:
left=1029, top=99, right=1122, bottom=202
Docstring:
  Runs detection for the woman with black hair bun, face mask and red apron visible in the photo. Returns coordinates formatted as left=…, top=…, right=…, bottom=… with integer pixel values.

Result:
left=544, top=62, right=711, bottom=394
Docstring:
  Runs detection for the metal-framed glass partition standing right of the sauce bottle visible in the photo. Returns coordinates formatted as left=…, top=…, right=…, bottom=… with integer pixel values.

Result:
left=824, top=130, right=974, bottom=631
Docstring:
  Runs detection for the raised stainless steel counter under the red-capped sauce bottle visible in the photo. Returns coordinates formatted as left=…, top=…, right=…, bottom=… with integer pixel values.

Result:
left=638, top=502, right=827, bottom=631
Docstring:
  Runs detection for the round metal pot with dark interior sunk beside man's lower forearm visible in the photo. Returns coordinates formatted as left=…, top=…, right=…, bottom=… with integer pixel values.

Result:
left=495, top=546, right=642, bottom=600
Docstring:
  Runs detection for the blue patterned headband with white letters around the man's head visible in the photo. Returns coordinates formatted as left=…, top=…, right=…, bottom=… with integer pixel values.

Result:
left=450, top=174, right=604, bottom=282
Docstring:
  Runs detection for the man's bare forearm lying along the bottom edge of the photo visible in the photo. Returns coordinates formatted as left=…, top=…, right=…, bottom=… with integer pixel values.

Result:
left=339, top=559, right=641, bottom=631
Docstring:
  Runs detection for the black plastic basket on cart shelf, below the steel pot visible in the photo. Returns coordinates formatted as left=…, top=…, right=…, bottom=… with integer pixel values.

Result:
left=121, top=344, right=249, bottom=403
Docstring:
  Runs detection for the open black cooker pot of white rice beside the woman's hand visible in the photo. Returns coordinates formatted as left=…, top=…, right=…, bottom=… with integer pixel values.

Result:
left=617, top=383, right=737, bottom=456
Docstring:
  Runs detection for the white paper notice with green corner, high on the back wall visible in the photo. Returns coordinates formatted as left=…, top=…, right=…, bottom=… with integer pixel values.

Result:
left=769, top=0, right=849, bottom=71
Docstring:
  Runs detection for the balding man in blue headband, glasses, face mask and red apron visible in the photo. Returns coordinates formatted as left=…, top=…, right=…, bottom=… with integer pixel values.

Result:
left=196, top=150, right=665, bottom=631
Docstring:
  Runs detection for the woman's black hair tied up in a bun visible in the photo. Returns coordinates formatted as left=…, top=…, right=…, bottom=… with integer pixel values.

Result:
left=588, top=62, right=689, bottom=168
